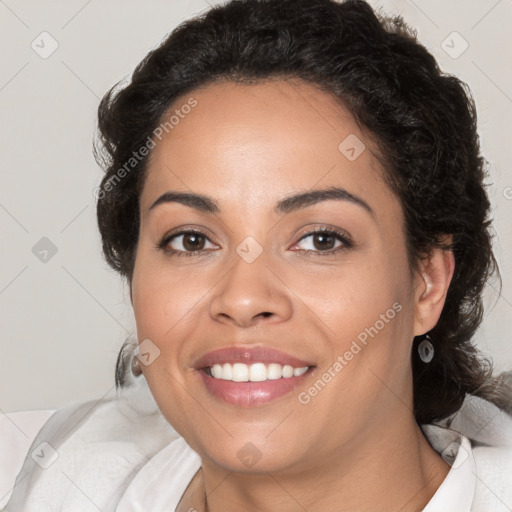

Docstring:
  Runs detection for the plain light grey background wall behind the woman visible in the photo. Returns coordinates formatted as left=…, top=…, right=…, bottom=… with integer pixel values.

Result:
left=0, top=0, right=512, bottom=413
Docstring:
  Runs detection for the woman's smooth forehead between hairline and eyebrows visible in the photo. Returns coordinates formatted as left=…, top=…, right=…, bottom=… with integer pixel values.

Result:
left=141, top=79, right=396, bottom=219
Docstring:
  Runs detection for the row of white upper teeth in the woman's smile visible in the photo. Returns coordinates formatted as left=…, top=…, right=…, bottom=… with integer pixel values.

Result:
left=210, top=363, right=309, bottom=382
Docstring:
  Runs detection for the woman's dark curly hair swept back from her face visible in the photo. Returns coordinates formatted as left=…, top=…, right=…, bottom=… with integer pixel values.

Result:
left=95, top=0, right=511, bottom=424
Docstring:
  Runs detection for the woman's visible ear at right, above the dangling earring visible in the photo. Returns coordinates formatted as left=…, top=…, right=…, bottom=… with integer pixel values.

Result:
left=414, top=235, right=455, bottom=336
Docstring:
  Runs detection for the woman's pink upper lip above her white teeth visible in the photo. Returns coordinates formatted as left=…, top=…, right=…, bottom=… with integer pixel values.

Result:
left=194, top=345, right=313, bottom=369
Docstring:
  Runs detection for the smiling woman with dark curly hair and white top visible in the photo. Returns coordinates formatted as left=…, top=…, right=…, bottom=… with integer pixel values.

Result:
left=6, top=0, right=512, bottom=512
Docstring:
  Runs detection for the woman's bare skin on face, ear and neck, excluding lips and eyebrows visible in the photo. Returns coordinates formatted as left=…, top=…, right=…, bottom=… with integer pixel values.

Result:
left=131, top=79, right=454, bottom=512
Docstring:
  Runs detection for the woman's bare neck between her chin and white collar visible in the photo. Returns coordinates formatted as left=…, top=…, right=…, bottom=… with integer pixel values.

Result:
left=177, top=421, right=449, bottom=512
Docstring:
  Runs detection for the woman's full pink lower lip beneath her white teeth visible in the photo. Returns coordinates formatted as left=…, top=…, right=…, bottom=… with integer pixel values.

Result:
left=199, top=368, right=312, bottom=407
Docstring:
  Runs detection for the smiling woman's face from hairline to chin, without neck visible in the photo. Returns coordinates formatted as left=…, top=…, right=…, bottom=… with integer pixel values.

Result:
left=131, top=80, right=428, bottom=471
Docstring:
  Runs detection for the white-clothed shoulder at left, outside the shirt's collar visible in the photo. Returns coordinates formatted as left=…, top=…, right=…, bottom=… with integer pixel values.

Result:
left=5, top=378, right=179, bottom=512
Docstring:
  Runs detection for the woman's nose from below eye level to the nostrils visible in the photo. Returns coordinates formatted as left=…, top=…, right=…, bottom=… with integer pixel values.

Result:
left=209, top=248, right=292, bottom=327
